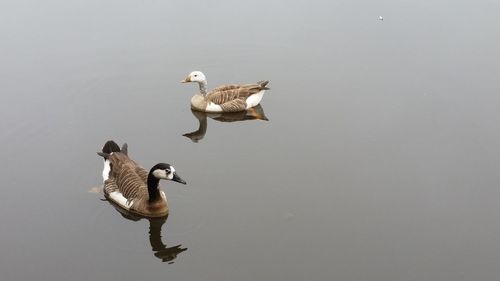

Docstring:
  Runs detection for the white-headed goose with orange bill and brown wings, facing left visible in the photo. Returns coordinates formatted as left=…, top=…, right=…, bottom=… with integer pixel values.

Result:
left=181, top=71, right=269, bottom=112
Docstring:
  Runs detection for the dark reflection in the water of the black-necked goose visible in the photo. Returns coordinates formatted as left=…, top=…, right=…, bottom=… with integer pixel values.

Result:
left=106, top=200, right=187, bottom=264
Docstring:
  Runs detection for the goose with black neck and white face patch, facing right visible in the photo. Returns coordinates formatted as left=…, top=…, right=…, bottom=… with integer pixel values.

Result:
left=97, top=140, right=186, bottom=217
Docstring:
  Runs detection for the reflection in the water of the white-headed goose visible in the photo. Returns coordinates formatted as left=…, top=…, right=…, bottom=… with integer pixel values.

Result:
left=183, top=104, right=269, bottom=142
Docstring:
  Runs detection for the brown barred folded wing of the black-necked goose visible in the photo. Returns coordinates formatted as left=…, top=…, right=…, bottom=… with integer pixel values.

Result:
left=105, top=152, right=147, bottom=200
